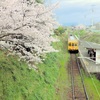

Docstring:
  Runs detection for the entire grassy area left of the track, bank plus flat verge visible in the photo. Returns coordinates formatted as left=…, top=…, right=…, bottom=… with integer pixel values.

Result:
left=0, top=32, right=68, bottom=100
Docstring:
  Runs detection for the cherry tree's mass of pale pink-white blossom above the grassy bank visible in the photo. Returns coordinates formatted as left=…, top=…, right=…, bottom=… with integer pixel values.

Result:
left=0, top=0, right=57, bottom=68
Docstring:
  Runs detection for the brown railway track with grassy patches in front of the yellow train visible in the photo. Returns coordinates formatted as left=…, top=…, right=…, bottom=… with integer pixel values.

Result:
left=70, top=54, right=89, bottom=100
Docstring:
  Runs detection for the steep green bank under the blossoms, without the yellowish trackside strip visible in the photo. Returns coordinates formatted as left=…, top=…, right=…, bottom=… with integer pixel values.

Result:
left=0, top=51, right=58, bottom=100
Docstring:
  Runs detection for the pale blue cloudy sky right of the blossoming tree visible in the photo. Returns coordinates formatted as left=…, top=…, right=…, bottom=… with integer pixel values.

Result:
left=46, top=0, right=100, bottom=26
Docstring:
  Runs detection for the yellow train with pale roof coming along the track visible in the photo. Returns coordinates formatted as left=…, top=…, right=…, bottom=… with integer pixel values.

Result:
left=68, top=35, right=78, bottom=53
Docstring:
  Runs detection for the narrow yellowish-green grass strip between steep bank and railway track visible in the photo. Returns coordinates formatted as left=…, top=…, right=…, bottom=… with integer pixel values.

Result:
left=52, top=34, right=69, bottom=100
